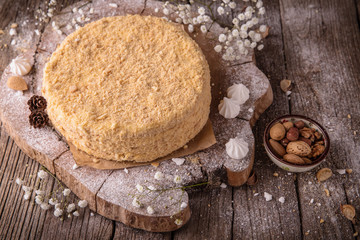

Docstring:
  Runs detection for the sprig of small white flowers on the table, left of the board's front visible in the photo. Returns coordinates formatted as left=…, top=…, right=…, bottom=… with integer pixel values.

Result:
left=15, top=166, right=88, bottom=221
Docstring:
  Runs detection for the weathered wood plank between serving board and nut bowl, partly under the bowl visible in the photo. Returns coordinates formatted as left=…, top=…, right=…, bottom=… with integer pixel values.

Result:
left=229, top=1, right=301, bottom=239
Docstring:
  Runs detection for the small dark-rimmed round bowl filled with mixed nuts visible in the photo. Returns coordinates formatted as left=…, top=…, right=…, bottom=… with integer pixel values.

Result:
left=264, top=115, right=330, bottom=172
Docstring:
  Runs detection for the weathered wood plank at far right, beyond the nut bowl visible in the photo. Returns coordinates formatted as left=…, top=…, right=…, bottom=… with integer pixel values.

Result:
left=280, top=0, right=360, bottom=239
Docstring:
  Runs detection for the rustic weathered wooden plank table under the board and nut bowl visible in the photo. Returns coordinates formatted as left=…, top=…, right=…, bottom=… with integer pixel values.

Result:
left=0, top=0, right=360, bottom=239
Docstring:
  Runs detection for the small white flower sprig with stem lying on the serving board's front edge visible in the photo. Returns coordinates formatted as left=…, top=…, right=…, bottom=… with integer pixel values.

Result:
left=128, top=171, right=208, bottom=225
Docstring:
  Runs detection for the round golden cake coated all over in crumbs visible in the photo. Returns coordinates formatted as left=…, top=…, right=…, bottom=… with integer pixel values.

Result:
left=42, top=15, right=211, bottom=162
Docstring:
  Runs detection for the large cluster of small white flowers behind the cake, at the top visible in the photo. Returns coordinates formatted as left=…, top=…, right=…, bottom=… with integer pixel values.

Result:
left=163, top=0, right=267, bottom=61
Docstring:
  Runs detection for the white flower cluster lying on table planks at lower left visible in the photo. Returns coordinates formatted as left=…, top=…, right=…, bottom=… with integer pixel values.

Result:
left=15, top=169, right=88, bottom=220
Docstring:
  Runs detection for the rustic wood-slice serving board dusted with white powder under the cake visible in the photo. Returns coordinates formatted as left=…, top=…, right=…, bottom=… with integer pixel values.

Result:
left=0, top=0, right=273, bottom=232
